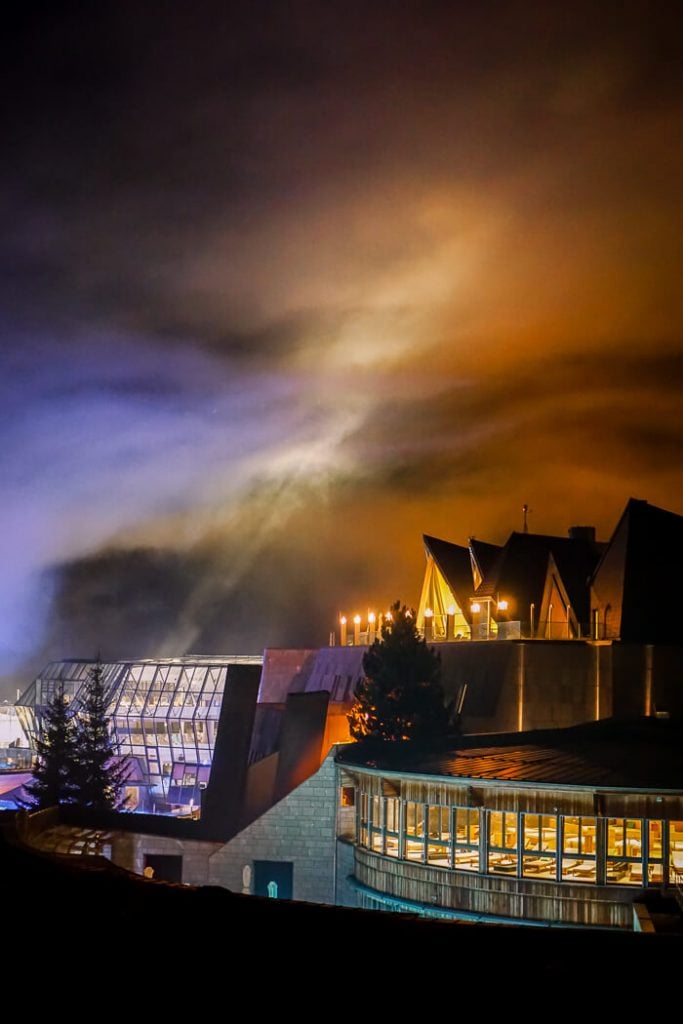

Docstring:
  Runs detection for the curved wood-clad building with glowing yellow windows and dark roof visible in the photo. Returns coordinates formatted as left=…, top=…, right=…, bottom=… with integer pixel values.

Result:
left=337, top=719, right=683, bottom=928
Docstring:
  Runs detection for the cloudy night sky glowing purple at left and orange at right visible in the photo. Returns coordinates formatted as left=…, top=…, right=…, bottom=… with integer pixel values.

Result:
left=0, top=0, right=683, bottom=695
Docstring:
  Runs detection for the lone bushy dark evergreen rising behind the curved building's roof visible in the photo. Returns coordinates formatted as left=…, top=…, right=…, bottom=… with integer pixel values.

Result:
left=348, top=601, right=449, bottom=741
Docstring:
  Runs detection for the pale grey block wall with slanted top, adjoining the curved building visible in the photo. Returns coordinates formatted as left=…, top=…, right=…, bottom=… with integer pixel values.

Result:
left=209, top=753, right=337, bottom=903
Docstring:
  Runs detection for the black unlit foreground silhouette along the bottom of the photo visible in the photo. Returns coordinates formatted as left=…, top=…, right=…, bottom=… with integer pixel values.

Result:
left=0, top=802, right=683, bottom=1003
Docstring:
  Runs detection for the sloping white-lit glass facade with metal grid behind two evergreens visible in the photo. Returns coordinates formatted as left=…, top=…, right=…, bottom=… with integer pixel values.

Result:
left=15, top=655, right=262, bottom=814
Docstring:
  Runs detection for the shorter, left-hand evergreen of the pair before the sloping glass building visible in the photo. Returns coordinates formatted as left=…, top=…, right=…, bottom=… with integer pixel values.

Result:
left=24, top=682, right=78, bottom=810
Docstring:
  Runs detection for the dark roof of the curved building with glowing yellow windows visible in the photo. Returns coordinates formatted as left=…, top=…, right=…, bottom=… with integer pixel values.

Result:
left=339, top=718, right=683, bottom=791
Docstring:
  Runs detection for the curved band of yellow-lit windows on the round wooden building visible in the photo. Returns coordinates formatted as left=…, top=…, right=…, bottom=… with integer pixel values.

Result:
left=356, top=793, right=683, bottom=888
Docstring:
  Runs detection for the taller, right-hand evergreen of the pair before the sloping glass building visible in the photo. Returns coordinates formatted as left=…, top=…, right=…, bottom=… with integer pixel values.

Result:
left=76, top=658, right=131, bottom=810
